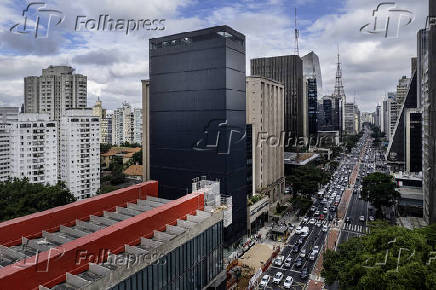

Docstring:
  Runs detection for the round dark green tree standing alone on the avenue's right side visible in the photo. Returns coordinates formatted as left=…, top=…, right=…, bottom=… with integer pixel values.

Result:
left=362, top=172, right=400, bottom=218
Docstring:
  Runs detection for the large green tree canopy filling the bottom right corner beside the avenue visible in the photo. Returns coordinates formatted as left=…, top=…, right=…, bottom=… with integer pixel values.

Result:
left=321, top=223, right=436, bottom=290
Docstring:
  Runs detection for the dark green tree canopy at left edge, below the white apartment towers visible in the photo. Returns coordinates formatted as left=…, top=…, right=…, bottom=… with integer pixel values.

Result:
left=0, top=178, right=76, bottom=221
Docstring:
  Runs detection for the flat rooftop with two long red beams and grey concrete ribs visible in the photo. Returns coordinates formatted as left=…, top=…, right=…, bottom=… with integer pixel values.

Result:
left=0, top=181, right=223, bottom=290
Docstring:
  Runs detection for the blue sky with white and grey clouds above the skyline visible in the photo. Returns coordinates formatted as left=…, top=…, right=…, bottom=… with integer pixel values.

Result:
left=0, top=0, right=429, bottom=111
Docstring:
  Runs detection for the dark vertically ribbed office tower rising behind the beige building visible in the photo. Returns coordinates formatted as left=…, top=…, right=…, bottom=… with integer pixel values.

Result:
left=251, top=55, right=308, bottom=140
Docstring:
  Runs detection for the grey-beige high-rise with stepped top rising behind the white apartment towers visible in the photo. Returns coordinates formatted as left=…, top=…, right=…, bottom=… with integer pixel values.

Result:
left=24, top=66, right=87, bottom=120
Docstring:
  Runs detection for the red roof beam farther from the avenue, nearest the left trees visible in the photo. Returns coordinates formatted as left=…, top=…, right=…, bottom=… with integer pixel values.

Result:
left=0, top=181, right=158, bottom=246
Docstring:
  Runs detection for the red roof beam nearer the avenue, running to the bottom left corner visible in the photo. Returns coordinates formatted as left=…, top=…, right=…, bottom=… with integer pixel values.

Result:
left=0, top=193, right=204, bottom=289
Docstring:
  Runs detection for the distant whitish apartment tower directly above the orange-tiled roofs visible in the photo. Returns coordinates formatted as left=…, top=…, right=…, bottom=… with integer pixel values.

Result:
left=112, top=102, right=133, bottom=145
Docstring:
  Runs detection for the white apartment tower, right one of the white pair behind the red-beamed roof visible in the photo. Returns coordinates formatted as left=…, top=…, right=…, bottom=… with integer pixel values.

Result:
left=59, top=108, right=100, bottom=199
